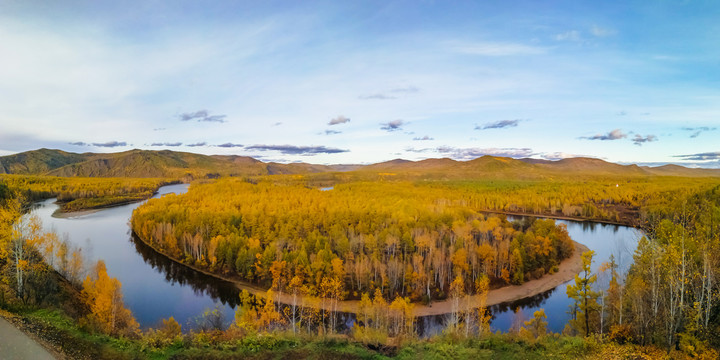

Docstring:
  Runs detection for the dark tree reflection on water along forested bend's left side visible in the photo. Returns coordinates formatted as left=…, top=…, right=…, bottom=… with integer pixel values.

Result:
left=130, top=234, right=240, bottom=307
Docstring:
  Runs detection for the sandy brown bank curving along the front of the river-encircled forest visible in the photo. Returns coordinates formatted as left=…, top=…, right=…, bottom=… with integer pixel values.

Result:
left=136, top=226, right=589, bottom=317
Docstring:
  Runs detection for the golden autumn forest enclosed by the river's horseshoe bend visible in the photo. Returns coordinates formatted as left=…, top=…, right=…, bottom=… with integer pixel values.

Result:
left=132, top=179, right=573, bottom=303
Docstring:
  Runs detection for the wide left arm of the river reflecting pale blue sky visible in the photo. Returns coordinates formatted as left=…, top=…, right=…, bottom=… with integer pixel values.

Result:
left=32, top=184, right=237, bottom=329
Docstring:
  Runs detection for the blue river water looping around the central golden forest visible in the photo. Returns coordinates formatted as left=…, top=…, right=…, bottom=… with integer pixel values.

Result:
left=32, top=184, right=640, bottom=334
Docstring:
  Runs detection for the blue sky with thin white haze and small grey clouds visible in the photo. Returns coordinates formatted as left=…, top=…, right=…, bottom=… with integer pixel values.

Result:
left=0, top=0, right=720, bottom=167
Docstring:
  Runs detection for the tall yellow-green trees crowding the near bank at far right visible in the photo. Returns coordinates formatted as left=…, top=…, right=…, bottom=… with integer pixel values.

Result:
left=567, top=186, right=720, bottom=358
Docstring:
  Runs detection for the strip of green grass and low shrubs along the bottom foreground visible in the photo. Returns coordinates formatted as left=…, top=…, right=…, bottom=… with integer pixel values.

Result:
left=5, top=309, right=683, bottom=360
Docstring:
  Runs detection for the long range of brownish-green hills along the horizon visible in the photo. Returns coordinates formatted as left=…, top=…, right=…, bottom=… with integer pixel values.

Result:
left=0, top=149, right=720, bottom=179
